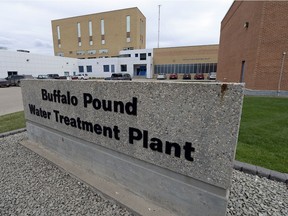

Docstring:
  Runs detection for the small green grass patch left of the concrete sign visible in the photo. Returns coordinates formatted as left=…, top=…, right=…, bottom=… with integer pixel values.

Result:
left=0, top=111, right=26, bottom=133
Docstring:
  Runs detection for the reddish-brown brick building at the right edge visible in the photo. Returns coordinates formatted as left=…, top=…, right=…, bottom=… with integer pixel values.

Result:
left=217, top=1, right=288, bottom=94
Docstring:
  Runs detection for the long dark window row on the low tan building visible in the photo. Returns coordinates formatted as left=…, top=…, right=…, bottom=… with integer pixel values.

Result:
left=154, top=63, right=217, bottom=74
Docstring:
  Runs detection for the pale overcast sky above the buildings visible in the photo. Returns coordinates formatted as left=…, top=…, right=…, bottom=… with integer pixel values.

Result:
left=0, top=0, right=233, bottom=55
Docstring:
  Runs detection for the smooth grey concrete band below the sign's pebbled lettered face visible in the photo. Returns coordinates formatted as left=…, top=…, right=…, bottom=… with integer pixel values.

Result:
left=26, top=122, right=228, bottom=216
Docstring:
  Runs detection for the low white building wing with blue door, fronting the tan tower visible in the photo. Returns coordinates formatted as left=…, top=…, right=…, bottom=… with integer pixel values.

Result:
left=0, top=49, right=153, bottom=78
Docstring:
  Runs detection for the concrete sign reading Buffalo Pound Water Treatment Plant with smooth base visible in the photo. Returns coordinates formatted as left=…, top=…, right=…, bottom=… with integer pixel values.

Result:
left=22, top=80, right=243, bottom=215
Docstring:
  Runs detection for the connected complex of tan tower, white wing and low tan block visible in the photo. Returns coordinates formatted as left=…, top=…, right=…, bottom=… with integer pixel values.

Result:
left=0, top=7, right=219, bottom=78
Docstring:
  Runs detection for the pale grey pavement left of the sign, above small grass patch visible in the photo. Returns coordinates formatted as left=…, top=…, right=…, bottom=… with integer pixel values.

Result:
left=0, top=87, right=24, bottom=116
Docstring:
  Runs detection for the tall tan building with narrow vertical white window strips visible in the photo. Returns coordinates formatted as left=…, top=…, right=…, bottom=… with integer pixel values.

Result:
left=52, top=7, right=146, bottom=59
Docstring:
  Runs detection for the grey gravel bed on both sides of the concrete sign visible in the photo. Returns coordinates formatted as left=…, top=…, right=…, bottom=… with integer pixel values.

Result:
left=0, top=132, right=288, bottom=216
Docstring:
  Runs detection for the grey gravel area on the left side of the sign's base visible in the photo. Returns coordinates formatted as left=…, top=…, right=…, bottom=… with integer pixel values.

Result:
left=0, top=132, right=133, bottom=216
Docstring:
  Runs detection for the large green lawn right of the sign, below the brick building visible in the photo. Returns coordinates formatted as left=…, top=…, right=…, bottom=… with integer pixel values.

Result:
left=236, top=96, right=288, bottom=173
